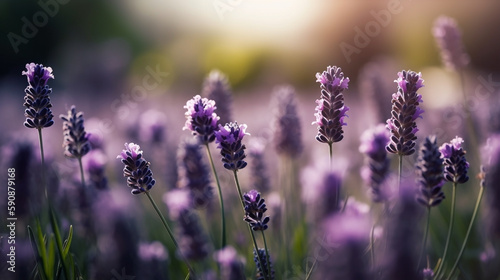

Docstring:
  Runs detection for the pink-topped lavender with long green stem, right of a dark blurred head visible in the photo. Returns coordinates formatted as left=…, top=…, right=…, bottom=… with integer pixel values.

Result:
left=436, top=136, right=469, bottom=277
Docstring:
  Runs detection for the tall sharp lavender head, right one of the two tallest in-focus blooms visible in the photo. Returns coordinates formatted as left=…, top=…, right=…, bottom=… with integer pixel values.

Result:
left=386, top=70, right=424, bottom=156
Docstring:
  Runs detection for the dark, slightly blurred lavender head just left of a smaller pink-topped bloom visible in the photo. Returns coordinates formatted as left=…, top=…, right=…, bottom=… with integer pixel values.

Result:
left=416, top=136, right=444, bottom=207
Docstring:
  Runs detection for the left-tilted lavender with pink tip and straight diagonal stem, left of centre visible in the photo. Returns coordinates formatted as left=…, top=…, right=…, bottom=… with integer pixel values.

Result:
left=116, top=143, right=195, bottom=277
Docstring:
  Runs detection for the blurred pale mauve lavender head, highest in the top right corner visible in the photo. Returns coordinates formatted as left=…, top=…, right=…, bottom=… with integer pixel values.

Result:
left=432, top=16, right=470, bottom=70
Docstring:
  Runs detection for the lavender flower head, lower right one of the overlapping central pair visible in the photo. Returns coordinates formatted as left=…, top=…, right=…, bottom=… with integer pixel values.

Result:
left=215, top=122, right=250, bottom=171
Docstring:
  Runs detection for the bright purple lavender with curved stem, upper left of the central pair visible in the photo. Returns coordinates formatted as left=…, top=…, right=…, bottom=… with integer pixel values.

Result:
left=183, top=95, right=226, bottom=248
